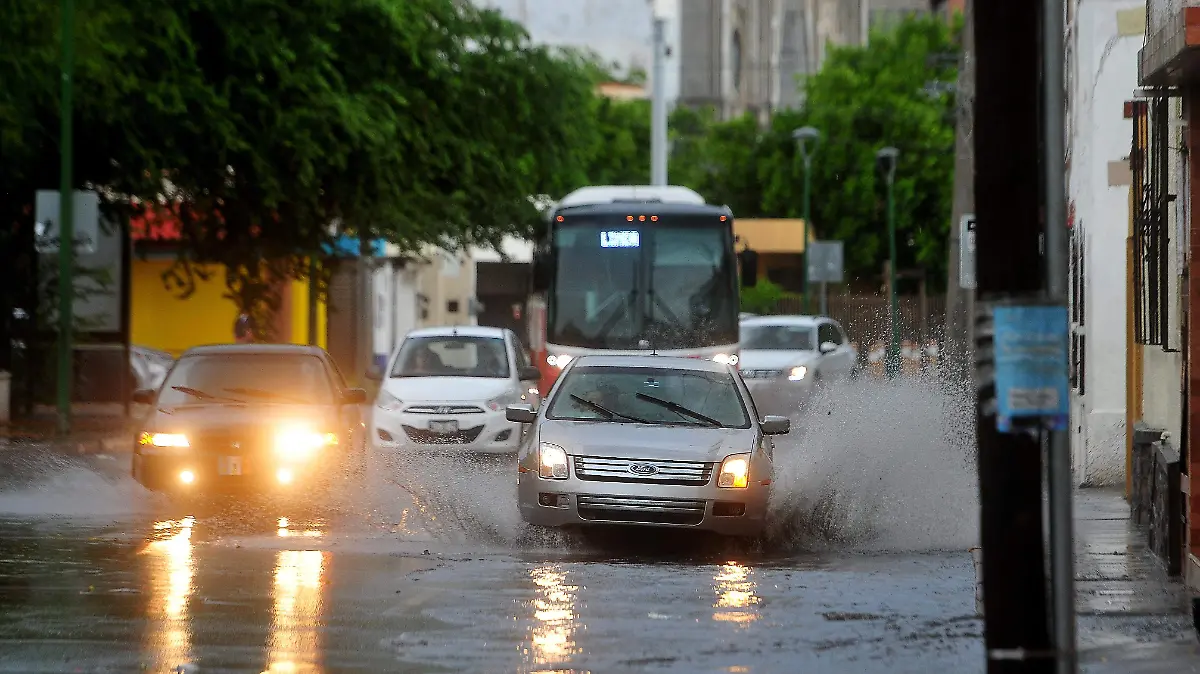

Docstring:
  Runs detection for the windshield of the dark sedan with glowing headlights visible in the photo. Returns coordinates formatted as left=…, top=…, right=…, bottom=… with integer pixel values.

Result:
left=158, top=354, right=334, bottom=407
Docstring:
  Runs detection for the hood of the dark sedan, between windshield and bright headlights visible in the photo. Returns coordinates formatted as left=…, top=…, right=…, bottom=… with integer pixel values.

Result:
left=146, top=403, right=338, bottom=433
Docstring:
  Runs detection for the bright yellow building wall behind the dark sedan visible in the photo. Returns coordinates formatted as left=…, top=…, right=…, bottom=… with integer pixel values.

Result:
left=130, top=259, right=325, bottom=356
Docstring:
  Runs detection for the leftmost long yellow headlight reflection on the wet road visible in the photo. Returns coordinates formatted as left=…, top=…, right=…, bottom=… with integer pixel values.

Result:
left=142, top=517, right=196, bottom=669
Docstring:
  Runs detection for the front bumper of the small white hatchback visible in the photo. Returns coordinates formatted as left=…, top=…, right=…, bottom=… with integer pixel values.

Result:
left=371, top=408, right=522, bottom=453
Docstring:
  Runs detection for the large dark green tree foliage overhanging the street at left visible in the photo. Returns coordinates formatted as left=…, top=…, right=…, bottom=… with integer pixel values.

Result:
left=0, top=0, right=596, bottom=333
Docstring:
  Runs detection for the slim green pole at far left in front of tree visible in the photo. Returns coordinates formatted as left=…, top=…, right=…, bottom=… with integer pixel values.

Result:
left=58, top=0, right=74, bottom=435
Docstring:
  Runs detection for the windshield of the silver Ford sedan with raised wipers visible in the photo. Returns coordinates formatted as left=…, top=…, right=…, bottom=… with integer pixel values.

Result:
left=546, top=366, right=750, bottom=428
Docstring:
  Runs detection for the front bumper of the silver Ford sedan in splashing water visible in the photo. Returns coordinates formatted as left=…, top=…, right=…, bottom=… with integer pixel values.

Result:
left=517, top=473, right=770, bottom=536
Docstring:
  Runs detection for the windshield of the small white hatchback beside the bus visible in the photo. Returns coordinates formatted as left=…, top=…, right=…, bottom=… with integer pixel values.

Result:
left=391, top=335, right=509, bottom=379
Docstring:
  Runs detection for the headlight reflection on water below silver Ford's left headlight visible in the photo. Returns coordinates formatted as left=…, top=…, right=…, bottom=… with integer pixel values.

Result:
left=524, top=564, right=582, bottom=668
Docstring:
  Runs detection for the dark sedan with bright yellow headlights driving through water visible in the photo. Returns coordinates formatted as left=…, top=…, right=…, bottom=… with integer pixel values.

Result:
left=132, top=344, right=366, bottom=492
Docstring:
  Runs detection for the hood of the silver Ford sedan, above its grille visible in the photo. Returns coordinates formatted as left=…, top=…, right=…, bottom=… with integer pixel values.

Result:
left=540, top=420, right=756, bottom=462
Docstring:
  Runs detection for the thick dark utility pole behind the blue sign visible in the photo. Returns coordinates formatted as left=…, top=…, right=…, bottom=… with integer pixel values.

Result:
left=970, top=2, right=1051, bottom=674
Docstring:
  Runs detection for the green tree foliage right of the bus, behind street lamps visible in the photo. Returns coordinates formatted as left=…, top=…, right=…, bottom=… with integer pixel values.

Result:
left=671, top=17, right=961, bottom=283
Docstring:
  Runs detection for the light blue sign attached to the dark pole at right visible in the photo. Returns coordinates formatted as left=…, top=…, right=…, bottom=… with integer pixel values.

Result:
left=994, top=306, right=1070, bottom=433
